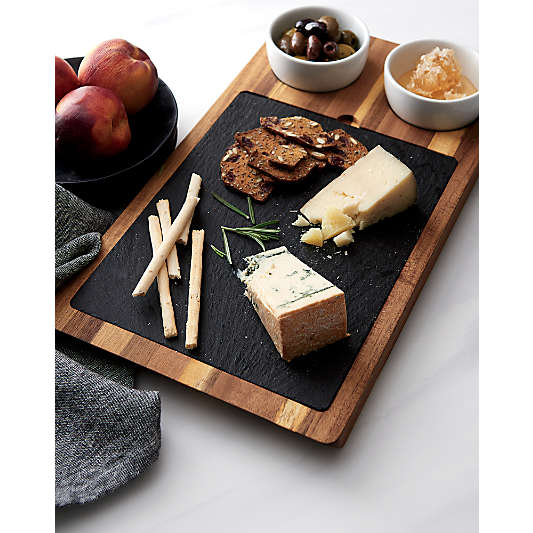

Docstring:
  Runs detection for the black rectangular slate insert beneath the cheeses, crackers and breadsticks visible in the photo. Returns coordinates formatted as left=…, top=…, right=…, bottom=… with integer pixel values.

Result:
left=71, top=92, right=457, bottom=410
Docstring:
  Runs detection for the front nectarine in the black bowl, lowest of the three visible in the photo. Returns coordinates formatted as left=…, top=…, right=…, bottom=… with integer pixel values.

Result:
left=56, top=87, right=131, bottom=158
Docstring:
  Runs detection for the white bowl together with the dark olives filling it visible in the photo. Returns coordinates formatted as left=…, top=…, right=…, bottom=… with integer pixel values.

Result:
left=266, top=6, right=370, bottom=92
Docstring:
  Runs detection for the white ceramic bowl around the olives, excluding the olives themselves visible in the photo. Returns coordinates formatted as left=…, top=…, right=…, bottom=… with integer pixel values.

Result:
left=266, top=6, right=370, bottom=92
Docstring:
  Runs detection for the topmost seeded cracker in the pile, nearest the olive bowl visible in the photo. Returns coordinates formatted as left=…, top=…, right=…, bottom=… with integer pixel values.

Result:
left=260, top=116, right=335, bottom=149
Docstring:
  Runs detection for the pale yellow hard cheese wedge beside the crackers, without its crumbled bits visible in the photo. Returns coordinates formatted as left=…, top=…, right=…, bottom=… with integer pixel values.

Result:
left=300, top=146, right=416, bottom=229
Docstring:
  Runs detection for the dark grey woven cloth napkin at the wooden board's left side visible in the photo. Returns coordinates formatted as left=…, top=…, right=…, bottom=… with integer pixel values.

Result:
left=55, top=185, right=161, bottom=506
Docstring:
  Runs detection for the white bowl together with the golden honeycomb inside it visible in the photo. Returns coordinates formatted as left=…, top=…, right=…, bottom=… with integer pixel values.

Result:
left=384, top=39, right=479, bottom=131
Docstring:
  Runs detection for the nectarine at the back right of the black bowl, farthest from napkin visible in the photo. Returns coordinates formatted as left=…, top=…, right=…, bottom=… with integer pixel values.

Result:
left=78, top=39, right=158, bottom=114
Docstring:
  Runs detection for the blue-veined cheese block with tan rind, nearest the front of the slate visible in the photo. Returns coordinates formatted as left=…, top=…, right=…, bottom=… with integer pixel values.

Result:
left=240, top=246, right=347, bottom=361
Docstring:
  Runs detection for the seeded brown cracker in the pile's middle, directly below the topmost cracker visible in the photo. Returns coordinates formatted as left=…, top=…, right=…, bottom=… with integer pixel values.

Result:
left=235, top=128, right=307, bottom=168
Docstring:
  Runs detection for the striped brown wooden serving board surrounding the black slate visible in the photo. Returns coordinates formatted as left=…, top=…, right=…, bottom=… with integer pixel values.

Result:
left=56, top=39, right=478, bottom=446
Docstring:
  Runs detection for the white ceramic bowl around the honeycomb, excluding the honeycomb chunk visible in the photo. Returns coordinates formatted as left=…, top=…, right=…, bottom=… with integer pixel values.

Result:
left=384, top=39, right=479, bottom=130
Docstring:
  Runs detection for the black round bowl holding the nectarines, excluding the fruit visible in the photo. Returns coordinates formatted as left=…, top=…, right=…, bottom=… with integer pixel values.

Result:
left=56, top=57, right=178, bottom=207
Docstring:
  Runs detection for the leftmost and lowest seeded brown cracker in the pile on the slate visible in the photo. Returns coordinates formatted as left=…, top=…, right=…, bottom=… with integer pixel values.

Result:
left=220, top=143, right=274, bottom=202
